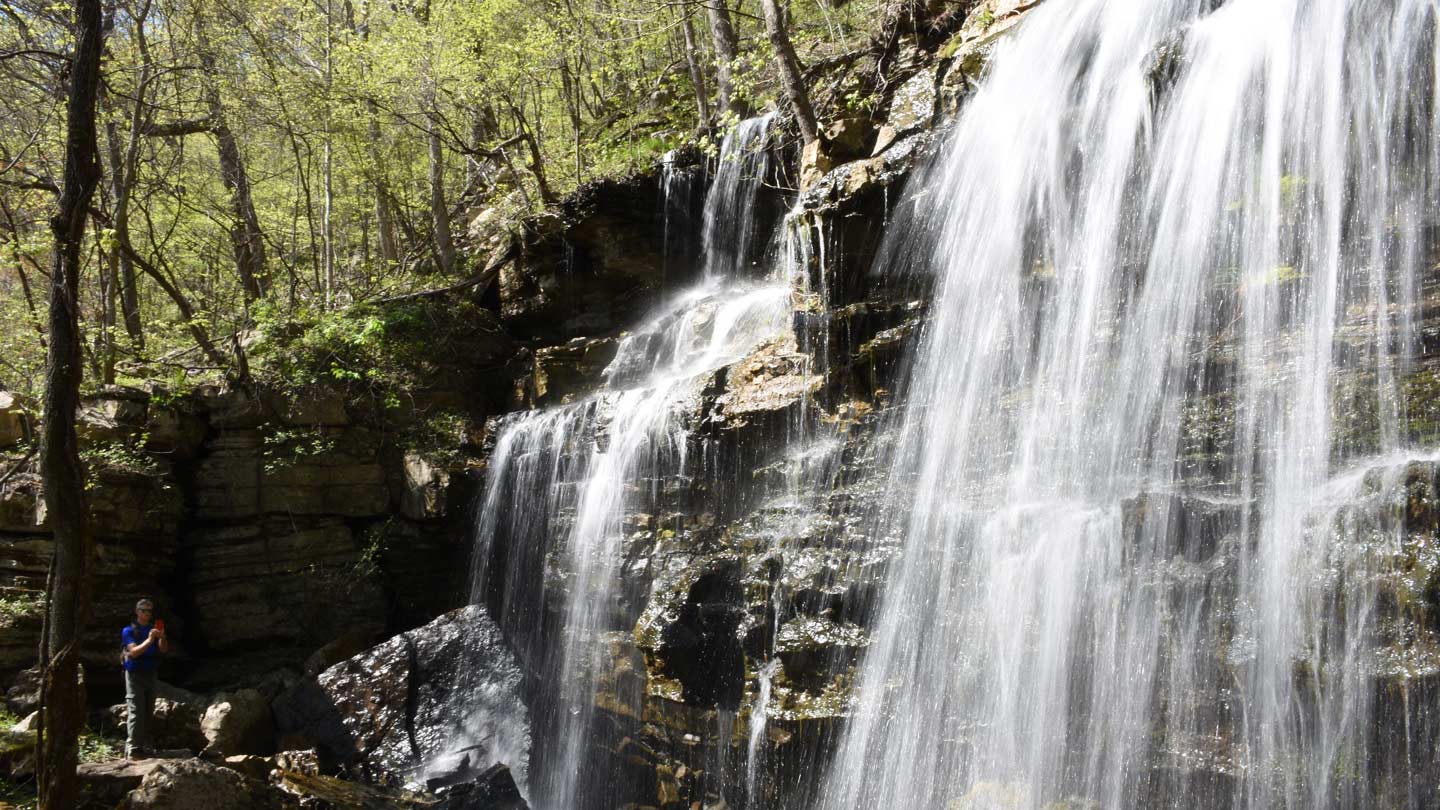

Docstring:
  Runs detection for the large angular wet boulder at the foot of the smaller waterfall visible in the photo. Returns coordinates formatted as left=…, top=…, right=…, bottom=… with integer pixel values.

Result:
left=274, top=605, right=530, bottom=781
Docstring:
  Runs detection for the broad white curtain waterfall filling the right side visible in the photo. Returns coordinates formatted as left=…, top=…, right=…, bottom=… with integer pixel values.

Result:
left=822, top=0, right=1440, bottom=810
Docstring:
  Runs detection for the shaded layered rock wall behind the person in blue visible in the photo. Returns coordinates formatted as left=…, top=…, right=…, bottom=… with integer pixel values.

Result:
left=0, top=305, right=516, bottom=691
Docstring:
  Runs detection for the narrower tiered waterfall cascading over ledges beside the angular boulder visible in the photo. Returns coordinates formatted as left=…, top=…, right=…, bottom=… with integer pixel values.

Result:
left=472, top=117, right=792, bottom=810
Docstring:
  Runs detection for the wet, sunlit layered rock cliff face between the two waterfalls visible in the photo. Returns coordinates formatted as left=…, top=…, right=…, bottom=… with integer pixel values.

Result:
left=449, top=33, right=961, bottom=809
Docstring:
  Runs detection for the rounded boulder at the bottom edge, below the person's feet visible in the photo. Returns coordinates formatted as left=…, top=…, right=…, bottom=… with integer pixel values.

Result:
left=121, top=760, right=284, bottom=810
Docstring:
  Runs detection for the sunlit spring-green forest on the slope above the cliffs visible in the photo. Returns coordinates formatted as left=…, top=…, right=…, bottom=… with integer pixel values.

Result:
left=0, top=0, right=881, bottom=402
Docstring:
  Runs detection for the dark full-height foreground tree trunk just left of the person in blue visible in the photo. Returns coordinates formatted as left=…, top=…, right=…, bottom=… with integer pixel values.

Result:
left=39, top=0, right=104, bottom=810
